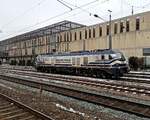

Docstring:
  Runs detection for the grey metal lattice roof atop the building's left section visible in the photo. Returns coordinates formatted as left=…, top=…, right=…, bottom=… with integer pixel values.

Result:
left=0, top=20, right=85, bottom=43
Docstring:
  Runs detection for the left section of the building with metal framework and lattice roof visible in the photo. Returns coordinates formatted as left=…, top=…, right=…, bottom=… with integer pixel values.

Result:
left=0, top=21, right=84, bottom=65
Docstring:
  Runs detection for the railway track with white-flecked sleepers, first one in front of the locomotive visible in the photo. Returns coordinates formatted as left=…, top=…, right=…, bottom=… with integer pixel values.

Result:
left=4, top=71, right=150, bottom=96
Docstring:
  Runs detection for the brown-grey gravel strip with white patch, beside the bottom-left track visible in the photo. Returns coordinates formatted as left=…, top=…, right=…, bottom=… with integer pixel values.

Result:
left=0, top=80, right=148, bottom=120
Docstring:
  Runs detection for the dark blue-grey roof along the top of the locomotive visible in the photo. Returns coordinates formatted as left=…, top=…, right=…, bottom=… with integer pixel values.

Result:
left=38, top=49, right=121, bottom=56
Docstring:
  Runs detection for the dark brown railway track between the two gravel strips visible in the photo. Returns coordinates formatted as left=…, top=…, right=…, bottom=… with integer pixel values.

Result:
left=0, top=71, right=150, bottom=118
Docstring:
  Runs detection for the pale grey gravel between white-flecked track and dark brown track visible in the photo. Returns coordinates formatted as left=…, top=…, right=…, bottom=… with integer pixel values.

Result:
left=4, top=73, right=150, bottom=105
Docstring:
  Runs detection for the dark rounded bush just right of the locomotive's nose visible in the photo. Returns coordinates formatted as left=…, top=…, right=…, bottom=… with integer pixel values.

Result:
left=129, top=56, right=144, bottom=70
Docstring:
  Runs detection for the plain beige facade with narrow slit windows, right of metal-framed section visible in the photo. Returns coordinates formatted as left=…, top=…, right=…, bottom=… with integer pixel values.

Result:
left=59, top=12, right=150, bottom=57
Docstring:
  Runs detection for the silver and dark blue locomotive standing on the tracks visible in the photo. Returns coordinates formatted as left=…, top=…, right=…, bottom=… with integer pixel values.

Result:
left=35, top=49, right=129, bottom=78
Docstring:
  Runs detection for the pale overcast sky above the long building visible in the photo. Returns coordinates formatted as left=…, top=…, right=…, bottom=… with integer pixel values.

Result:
left=0, top=0, right=150, bottom=40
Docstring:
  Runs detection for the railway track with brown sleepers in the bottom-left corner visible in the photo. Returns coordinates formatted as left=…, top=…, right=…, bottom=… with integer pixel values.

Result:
left=0, top=93, right=54, bottom=120
